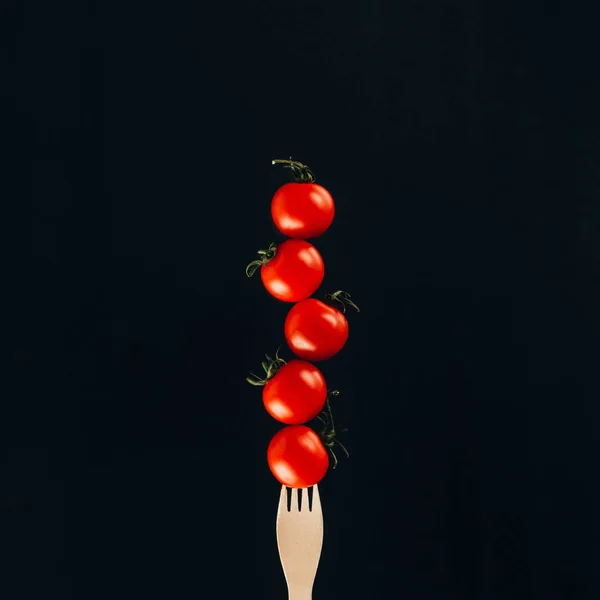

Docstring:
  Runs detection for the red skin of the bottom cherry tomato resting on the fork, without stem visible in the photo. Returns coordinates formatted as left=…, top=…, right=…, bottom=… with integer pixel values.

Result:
left=267, top=425, right=329, bottom=488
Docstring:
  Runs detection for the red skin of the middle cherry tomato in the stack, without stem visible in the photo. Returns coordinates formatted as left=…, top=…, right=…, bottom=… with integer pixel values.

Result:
left=284, top=298, right=348, bottom=362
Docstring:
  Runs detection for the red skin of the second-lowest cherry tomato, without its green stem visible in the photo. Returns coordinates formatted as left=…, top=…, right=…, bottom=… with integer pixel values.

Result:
left=263, top=359, right=327, bottom=425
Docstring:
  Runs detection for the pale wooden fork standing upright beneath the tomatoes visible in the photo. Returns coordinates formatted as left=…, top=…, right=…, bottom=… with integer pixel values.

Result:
left=277, top=485, right=323, bottom=600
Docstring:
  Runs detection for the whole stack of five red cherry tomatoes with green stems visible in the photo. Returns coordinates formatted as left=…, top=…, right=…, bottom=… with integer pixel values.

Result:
left=246, top=159, right=358, bottom=488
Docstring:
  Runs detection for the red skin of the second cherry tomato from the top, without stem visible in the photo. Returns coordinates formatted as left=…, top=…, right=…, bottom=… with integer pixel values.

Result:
left=260, top=240, right=325, bottom=302
